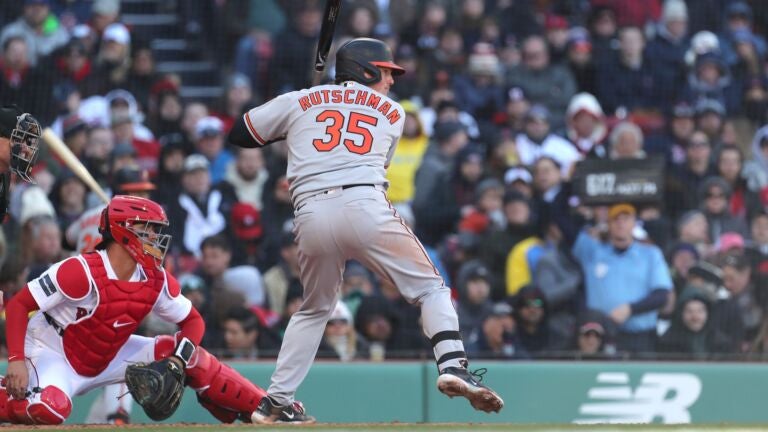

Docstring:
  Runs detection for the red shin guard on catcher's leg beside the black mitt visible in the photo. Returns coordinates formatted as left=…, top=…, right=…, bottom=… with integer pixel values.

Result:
left=186, top=347, right=267, bottom=423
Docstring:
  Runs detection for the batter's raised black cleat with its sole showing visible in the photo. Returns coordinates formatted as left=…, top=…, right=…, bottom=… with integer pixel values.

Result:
left=437, top=367, right=504, bottom=413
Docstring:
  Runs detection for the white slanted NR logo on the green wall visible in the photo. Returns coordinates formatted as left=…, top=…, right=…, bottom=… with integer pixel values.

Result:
left=574, top=372, right=701, bottom=424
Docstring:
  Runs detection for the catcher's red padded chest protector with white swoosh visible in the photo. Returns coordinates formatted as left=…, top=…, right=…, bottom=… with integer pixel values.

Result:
left=63, top=253, right=165, bottom=377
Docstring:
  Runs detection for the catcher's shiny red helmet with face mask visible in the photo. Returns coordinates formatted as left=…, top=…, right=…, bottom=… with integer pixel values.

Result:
left=99, top=195, right=171, bottom=268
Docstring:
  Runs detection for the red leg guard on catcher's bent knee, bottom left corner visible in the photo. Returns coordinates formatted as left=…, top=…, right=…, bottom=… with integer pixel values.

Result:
left=0, top=386, right=72, bottom=425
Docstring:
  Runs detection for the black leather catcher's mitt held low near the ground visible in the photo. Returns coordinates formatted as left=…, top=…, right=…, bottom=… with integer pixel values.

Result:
left=125, top=359, right=184, bottom=421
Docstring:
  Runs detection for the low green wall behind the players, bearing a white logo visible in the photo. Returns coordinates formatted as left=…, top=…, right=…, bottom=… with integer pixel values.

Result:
left=6, top=362, right=768, bottom=423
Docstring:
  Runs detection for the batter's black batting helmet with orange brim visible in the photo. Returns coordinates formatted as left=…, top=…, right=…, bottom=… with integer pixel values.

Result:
left=336, top=38, right=405, bottom=85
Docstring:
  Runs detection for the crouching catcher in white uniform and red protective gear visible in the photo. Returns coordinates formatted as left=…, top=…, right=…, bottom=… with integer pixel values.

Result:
left=0, top=195, right=303, bottom=424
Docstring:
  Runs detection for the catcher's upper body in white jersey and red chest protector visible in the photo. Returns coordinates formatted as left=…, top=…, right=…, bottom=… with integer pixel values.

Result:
left=28, top=251, right=192, bottom=376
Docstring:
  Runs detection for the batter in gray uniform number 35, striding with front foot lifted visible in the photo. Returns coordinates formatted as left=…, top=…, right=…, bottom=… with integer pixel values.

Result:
left=230, top=38, right=503, bottom=423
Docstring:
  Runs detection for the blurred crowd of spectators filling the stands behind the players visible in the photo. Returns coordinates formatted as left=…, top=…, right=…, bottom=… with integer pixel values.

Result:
left=0, top=0, right=768, bottom=361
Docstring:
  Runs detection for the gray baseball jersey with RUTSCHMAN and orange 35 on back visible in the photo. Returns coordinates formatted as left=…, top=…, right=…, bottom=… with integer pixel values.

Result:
left=245, top=81, right=405, bottom=205
